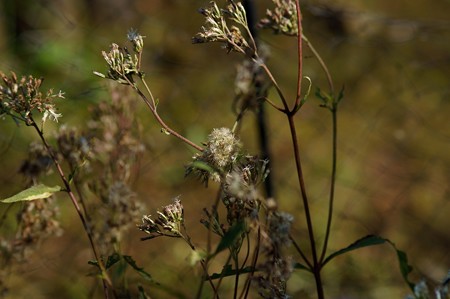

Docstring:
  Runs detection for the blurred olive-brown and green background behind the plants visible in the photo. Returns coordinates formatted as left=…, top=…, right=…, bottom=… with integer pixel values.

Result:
left=0, top=0, right=450, bottom=299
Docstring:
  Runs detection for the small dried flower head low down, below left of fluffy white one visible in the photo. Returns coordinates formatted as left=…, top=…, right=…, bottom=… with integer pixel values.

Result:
left=138, top=197, right=184, bottom=239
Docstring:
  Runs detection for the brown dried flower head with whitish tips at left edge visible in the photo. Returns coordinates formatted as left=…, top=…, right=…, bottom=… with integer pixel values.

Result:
left=0, top=72, right=64, bottom=125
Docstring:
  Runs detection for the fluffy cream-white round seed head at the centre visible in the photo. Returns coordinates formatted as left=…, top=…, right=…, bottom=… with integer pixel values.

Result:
left=186, top=128, right=241, bottom=184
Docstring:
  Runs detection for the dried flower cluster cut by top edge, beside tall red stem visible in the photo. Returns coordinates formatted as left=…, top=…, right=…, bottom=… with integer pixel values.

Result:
left=258, top=0, right=298, bottom=36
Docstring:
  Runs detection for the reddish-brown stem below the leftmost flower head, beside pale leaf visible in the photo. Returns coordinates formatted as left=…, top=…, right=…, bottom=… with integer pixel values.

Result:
left=31, top=119, right=112, bottom=298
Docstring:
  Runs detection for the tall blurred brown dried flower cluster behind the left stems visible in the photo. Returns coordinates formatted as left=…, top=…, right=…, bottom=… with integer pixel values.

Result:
left=85, top=86, right=145, bottom=250
